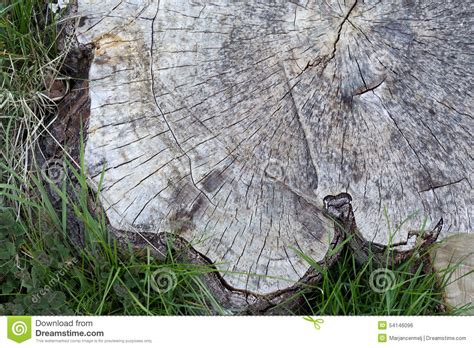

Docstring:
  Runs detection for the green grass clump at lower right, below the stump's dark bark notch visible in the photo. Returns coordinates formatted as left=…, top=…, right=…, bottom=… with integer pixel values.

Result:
left=296, top=240, right=470, bottom=315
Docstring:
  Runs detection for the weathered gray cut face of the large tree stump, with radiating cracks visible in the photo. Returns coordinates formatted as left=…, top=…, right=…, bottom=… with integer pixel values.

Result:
left=72, top=0, right=474, bottom=294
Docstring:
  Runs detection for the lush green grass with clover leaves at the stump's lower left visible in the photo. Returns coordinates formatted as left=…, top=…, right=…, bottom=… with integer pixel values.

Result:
left=0, top=154, right=228, bottom=315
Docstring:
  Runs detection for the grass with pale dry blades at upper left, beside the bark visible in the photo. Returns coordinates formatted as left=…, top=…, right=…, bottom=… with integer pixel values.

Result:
left=0, top=0, right=65, bottom=196
